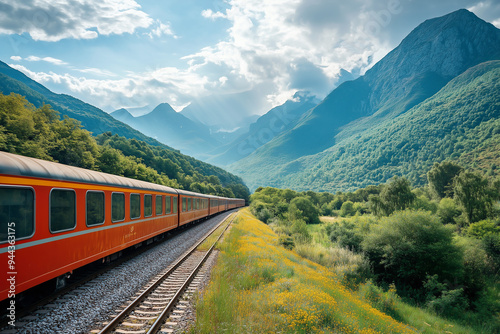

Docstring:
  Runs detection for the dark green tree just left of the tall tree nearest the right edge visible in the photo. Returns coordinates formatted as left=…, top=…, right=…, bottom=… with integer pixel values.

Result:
left=427, top=161, right=462, bottom=199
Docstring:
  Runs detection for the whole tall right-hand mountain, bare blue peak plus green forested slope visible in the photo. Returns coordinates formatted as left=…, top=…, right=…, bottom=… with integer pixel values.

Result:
left=228, top=10, right=500, bottom=191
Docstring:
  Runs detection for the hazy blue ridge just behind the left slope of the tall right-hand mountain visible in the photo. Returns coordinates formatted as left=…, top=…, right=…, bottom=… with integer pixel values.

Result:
left=208, top=92, right=319, bottom=166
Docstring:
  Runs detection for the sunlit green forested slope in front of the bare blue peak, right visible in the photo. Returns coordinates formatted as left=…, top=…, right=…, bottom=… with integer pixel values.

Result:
left=250, top=61, right=500, bottom=192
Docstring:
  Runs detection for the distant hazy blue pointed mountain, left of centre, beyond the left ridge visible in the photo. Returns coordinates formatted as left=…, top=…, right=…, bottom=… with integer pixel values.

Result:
left=111, top=103, right=219, bottom=158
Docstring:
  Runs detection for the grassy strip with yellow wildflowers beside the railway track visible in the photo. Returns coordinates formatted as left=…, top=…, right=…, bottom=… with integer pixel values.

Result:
left=191, top=209, right=417, bottom=333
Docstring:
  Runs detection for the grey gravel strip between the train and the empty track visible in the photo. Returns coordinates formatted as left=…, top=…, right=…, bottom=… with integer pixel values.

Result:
left=9, top=213, right=229, bottom=334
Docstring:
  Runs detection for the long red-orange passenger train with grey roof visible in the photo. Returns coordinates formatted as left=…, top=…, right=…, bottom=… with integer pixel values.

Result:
left=0, top=152, right=245, bottom=301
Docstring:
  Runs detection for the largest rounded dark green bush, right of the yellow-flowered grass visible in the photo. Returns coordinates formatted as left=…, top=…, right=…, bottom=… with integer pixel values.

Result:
left=362, top=210, right=462, bottom=296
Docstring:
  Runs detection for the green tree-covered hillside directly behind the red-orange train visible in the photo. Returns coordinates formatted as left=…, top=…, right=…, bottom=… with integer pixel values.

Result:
left=0, top=94, right=249, bottom=198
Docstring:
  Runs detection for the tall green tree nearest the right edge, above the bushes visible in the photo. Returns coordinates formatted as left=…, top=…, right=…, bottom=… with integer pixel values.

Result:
left=453, top=172, right=496, bottom=224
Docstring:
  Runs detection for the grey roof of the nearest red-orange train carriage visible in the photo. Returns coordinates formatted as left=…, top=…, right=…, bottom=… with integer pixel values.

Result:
left=0, top=152, right=178, bottom=194
